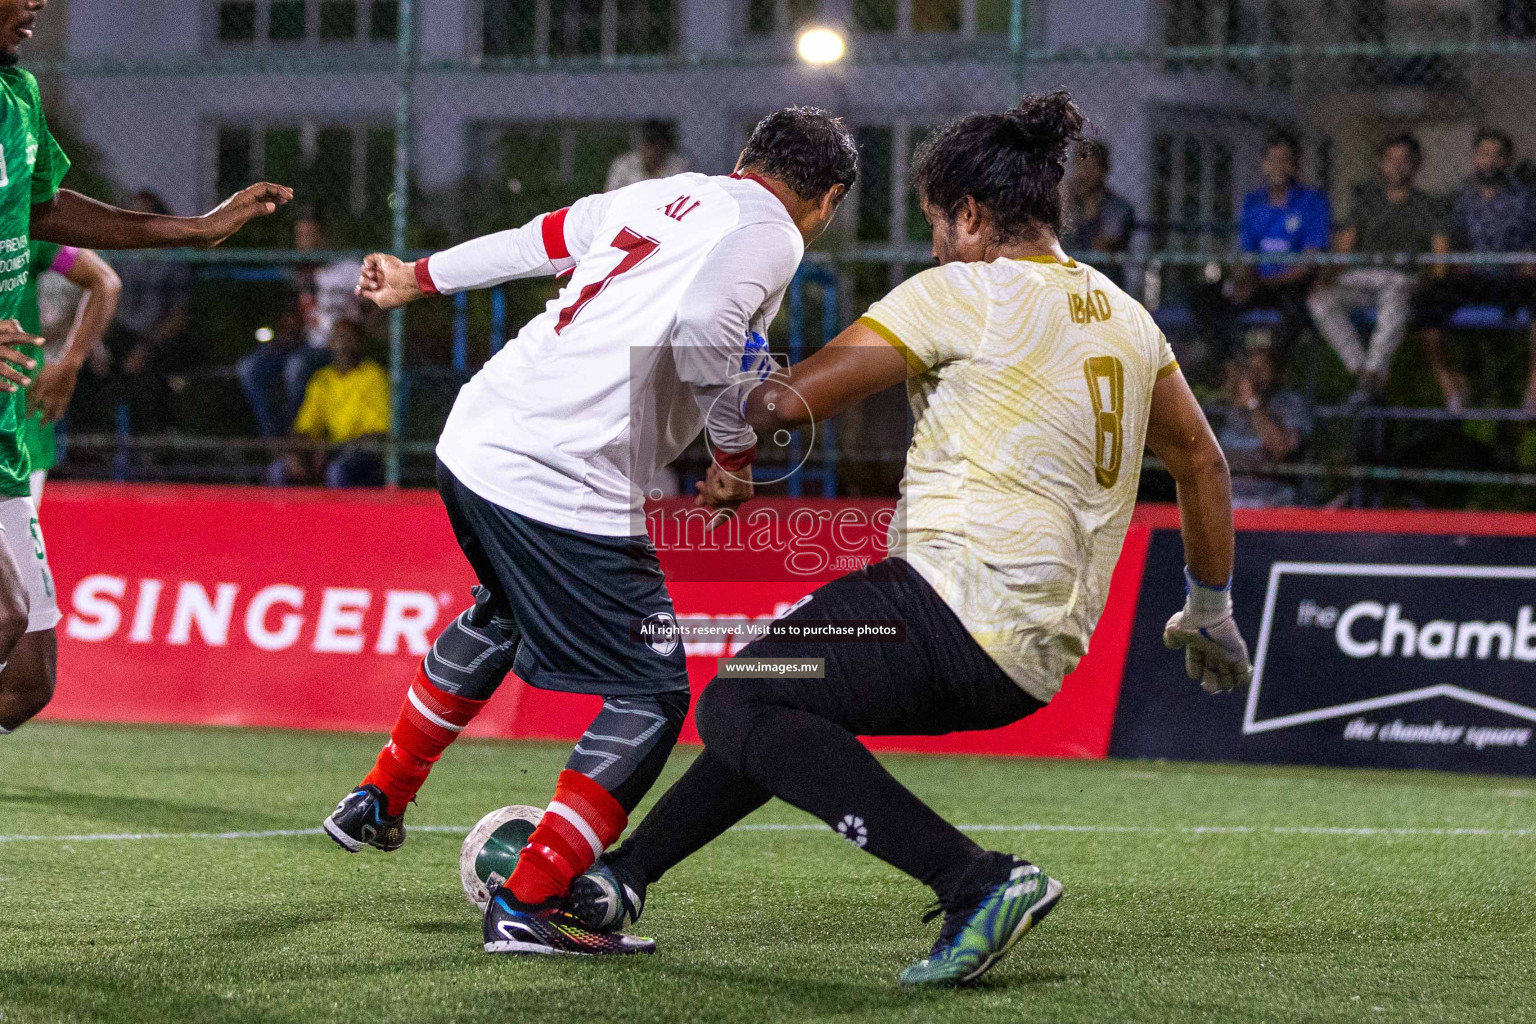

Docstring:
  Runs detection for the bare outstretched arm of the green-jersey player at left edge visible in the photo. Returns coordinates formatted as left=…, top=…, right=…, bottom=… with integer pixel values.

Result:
left=31, top=181, right=293, bottom=249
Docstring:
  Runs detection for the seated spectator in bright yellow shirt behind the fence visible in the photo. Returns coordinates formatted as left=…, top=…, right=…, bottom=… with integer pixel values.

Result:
left=267, top=319, right=390, bottom=487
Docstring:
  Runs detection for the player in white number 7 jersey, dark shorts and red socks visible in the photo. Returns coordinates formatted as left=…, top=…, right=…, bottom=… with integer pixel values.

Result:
left=326, top=107, right=857, bottom=953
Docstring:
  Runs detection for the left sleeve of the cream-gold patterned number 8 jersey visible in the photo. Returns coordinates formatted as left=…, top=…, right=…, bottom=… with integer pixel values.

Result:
left=859, top=263, right=988, bottom=373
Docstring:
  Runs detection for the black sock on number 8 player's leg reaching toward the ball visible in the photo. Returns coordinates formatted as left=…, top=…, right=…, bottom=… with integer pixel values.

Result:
left=611, top=751, right=768, bottom=884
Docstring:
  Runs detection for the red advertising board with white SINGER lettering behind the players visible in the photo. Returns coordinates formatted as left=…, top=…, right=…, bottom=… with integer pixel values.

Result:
left=41, top=484, right=1149, bottom=757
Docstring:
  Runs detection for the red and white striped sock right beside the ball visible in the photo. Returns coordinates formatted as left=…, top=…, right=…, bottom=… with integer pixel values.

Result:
left=507, top=769, right=630, bottom=903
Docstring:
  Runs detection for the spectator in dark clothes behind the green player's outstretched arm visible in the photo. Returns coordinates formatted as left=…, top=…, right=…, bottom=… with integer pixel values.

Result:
left=72, top=189, right=192, bottom=433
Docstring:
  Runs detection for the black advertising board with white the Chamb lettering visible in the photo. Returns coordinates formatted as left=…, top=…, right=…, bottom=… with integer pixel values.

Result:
left=1109, top=530, right=1536, bottom=775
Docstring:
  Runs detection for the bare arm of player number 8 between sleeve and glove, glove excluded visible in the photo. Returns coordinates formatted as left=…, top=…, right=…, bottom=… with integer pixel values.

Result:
left=1147, top=370, right=1235, bottom=586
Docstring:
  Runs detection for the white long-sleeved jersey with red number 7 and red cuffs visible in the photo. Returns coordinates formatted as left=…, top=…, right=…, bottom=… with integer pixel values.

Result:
left=416, top=173, right=805, bottom=536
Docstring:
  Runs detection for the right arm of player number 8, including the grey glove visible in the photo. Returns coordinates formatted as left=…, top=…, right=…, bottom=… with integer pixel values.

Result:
left=1147, top=368, right=1253, bottom=692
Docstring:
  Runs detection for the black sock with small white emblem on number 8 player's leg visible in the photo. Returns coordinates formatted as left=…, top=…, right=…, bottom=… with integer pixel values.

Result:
left=740, top=705, right=985, bottom=901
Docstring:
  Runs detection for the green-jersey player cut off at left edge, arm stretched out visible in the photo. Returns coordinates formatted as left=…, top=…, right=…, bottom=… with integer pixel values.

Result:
left=0, top=0, right=293, bottom=735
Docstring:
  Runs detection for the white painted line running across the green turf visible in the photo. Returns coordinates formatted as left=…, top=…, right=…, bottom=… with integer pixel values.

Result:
left=0, top=823, right=1536, bottom=843
